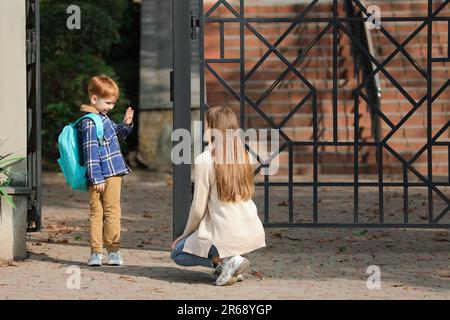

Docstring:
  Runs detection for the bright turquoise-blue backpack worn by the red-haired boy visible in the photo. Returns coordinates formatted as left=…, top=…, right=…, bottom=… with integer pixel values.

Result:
left=58, top=113, right=103, bottom=191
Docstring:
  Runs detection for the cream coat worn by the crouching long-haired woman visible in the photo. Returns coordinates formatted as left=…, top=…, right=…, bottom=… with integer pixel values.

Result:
left=181, top=149, right=266, bottom=258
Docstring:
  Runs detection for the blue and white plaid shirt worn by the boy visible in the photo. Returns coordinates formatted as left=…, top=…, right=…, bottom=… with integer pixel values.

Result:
left=78, top=114, right=133, bottom=185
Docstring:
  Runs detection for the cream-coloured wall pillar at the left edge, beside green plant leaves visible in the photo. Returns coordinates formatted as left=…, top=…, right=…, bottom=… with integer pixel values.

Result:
left=0, top=0, right=27, bottom=260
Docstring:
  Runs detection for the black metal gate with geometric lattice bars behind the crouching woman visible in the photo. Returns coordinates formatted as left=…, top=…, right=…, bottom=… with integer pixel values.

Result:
left=173, top=0, right=450, bottom=235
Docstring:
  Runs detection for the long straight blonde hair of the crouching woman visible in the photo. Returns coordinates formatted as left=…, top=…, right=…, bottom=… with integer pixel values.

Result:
left=206, top=106, right=255, bottom=202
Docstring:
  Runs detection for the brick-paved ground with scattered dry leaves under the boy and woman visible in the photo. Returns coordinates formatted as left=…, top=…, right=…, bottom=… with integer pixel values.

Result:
left=0, top=172, right=450, bottom=299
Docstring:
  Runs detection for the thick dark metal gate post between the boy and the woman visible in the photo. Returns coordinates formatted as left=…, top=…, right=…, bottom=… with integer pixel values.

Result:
left=172, top=0, right=191, bottom=238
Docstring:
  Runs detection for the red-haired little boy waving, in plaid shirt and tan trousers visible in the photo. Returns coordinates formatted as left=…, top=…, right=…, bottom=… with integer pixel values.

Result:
left=78, top=76, right=134, bottom=266
